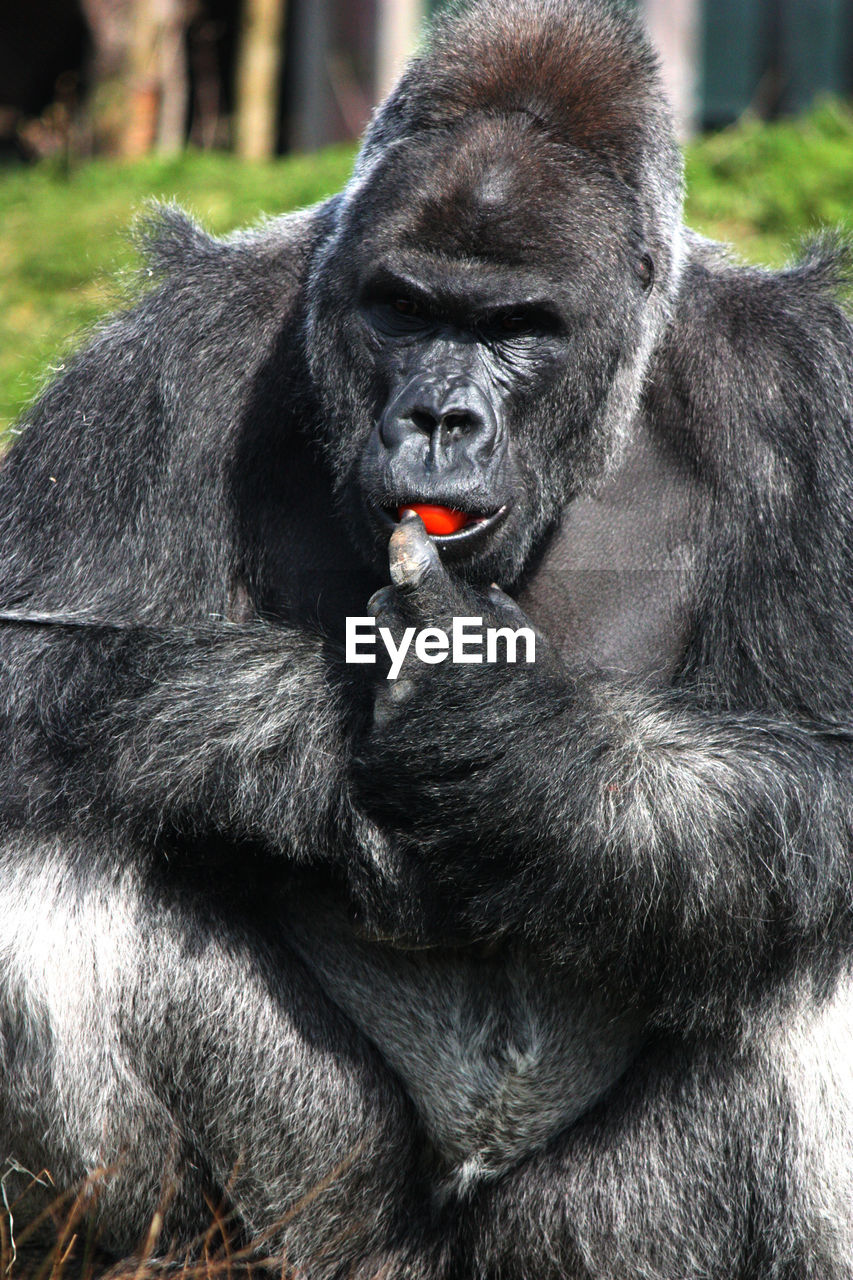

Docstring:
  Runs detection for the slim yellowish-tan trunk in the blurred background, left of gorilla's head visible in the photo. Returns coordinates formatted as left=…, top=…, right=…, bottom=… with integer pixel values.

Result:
left=234, top=0, right=286, bottom=160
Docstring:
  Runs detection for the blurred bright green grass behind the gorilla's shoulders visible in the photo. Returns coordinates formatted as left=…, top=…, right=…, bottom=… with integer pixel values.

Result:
left=0, top=101, right=853, bottom=433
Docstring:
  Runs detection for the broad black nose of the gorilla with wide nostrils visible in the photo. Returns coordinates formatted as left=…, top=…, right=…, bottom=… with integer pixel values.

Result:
left=379, top=384, right=498, bottom=461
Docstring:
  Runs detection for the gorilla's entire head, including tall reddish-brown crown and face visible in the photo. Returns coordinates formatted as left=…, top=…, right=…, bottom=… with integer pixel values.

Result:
left=309, top=0, right=681, bottom=584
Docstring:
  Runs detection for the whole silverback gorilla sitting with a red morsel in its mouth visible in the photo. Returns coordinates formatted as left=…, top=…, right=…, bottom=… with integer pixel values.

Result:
left=0, top=0, right=853, bottom=1280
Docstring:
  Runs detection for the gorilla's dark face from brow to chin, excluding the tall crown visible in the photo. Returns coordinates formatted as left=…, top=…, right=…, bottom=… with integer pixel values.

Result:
left=310, top=113, right=660, bottom=585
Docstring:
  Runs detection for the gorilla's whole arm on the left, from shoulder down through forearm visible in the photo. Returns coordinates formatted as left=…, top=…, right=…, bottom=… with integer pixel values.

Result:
left=0, top=212, right=368, bottom=870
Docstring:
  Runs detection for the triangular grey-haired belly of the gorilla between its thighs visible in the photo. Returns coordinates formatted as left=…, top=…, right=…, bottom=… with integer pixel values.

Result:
left=281, top=902, right=642, bottom=1185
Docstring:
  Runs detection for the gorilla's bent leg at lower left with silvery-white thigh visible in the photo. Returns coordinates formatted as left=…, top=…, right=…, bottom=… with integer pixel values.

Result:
left=0, top=820, right=425, bottom=1277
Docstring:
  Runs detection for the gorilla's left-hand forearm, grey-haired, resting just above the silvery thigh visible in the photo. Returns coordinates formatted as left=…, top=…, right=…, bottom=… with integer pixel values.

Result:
left=3, top=623, right=346, bottom=859
